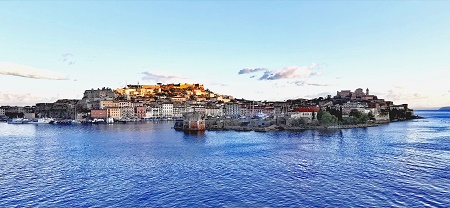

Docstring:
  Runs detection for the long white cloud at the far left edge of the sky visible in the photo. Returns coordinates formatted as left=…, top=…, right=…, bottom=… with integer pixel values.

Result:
left=0, top=62, right=69, bottom=80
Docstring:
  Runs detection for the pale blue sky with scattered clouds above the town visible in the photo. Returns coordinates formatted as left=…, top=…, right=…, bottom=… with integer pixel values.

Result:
left=0, top=1, right=450, bottom=109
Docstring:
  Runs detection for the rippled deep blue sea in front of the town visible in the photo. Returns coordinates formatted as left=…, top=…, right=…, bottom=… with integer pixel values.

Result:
left=0, top=111, right=450, bottom=207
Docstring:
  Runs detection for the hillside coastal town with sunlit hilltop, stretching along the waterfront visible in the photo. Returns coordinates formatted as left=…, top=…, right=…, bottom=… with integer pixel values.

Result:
left=0, top=83, right=414, bottom=128
